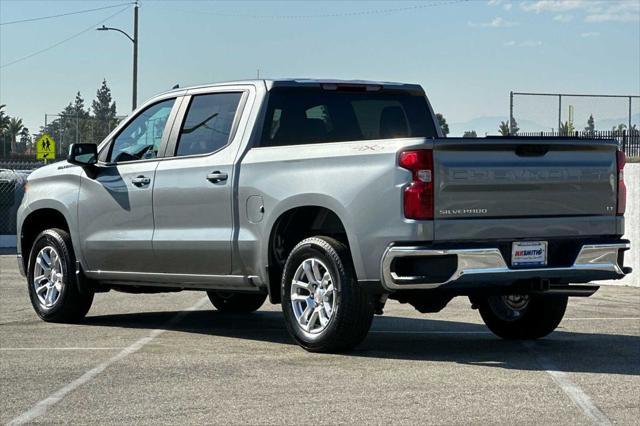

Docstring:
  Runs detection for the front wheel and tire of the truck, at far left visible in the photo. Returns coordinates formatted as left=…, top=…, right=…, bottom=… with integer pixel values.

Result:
left=27, top=228, right=93, bottom=323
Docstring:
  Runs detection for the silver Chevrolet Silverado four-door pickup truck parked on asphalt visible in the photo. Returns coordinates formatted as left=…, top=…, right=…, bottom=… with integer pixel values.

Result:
left=18, top=80, right=631, bottom=351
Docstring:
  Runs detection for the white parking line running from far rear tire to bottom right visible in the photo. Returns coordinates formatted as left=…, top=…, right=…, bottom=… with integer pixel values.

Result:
left=523, top=342, right=612, bottom=425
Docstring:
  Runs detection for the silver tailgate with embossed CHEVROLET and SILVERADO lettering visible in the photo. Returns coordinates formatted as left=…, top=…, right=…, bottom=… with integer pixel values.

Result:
left=434, top=138, right=617, bottom=230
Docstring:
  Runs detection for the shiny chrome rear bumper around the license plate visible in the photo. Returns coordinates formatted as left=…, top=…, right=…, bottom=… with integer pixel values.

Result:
left=381, top=242, right=630, bottom=291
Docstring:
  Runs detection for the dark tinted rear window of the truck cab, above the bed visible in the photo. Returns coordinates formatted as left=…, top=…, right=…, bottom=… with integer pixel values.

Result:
left=260, top=87, right=437, bottom=147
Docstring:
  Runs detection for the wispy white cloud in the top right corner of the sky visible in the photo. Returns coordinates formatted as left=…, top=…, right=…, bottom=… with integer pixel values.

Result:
left=520, top=0, right=640, bottom=22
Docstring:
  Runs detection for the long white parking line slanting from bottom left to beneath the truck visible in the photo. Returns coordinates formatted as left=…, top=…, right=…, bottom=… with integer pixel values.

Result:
left=8, top=297, right=209, bottom=425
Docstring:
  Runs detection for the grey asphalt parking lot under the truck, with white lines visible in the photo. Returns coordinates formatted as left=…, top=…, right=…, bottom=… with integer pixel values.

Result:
left=0, top=256, right=640, bottom=424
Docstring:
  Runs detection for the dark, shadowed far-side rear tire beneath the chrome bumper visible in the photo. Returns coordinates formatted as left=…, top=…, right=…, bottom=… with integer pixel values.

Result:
left=478, top=295, right=568, bottom=340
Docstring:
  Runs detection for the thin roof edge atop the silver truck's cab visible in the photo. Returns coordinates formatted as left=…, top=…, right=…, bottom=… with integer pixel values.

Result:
left=162, top=78, right=422, bottom=95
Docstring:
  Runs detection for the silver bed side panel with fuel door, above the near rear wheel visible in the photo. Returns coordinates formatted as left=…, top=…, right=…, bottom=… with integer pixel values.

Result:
left=236, top=138, right=433, bottom=280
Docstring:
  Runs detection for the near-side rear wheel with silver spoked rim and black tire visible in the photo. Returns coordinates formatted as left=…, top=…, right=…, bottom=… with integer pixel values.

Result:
left=281, top=237, right=374, bottom=352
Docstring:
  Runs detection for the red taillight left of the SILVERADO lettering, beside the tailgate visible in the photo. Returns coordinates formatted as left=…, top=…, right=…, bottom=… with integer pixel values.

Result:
left=399, top=149, right=433, bottom=220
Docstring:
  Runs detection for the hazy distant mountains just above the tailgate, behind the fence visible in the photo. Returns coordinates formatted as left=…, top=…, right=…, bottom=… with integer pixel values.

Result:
left=449, top=113, right=640, bottom=136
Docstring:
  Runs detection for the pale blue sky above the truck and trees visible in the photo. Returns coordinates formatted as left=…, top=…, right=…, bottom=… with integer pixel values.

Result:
left=0, top=0, right=640, bottom=132
